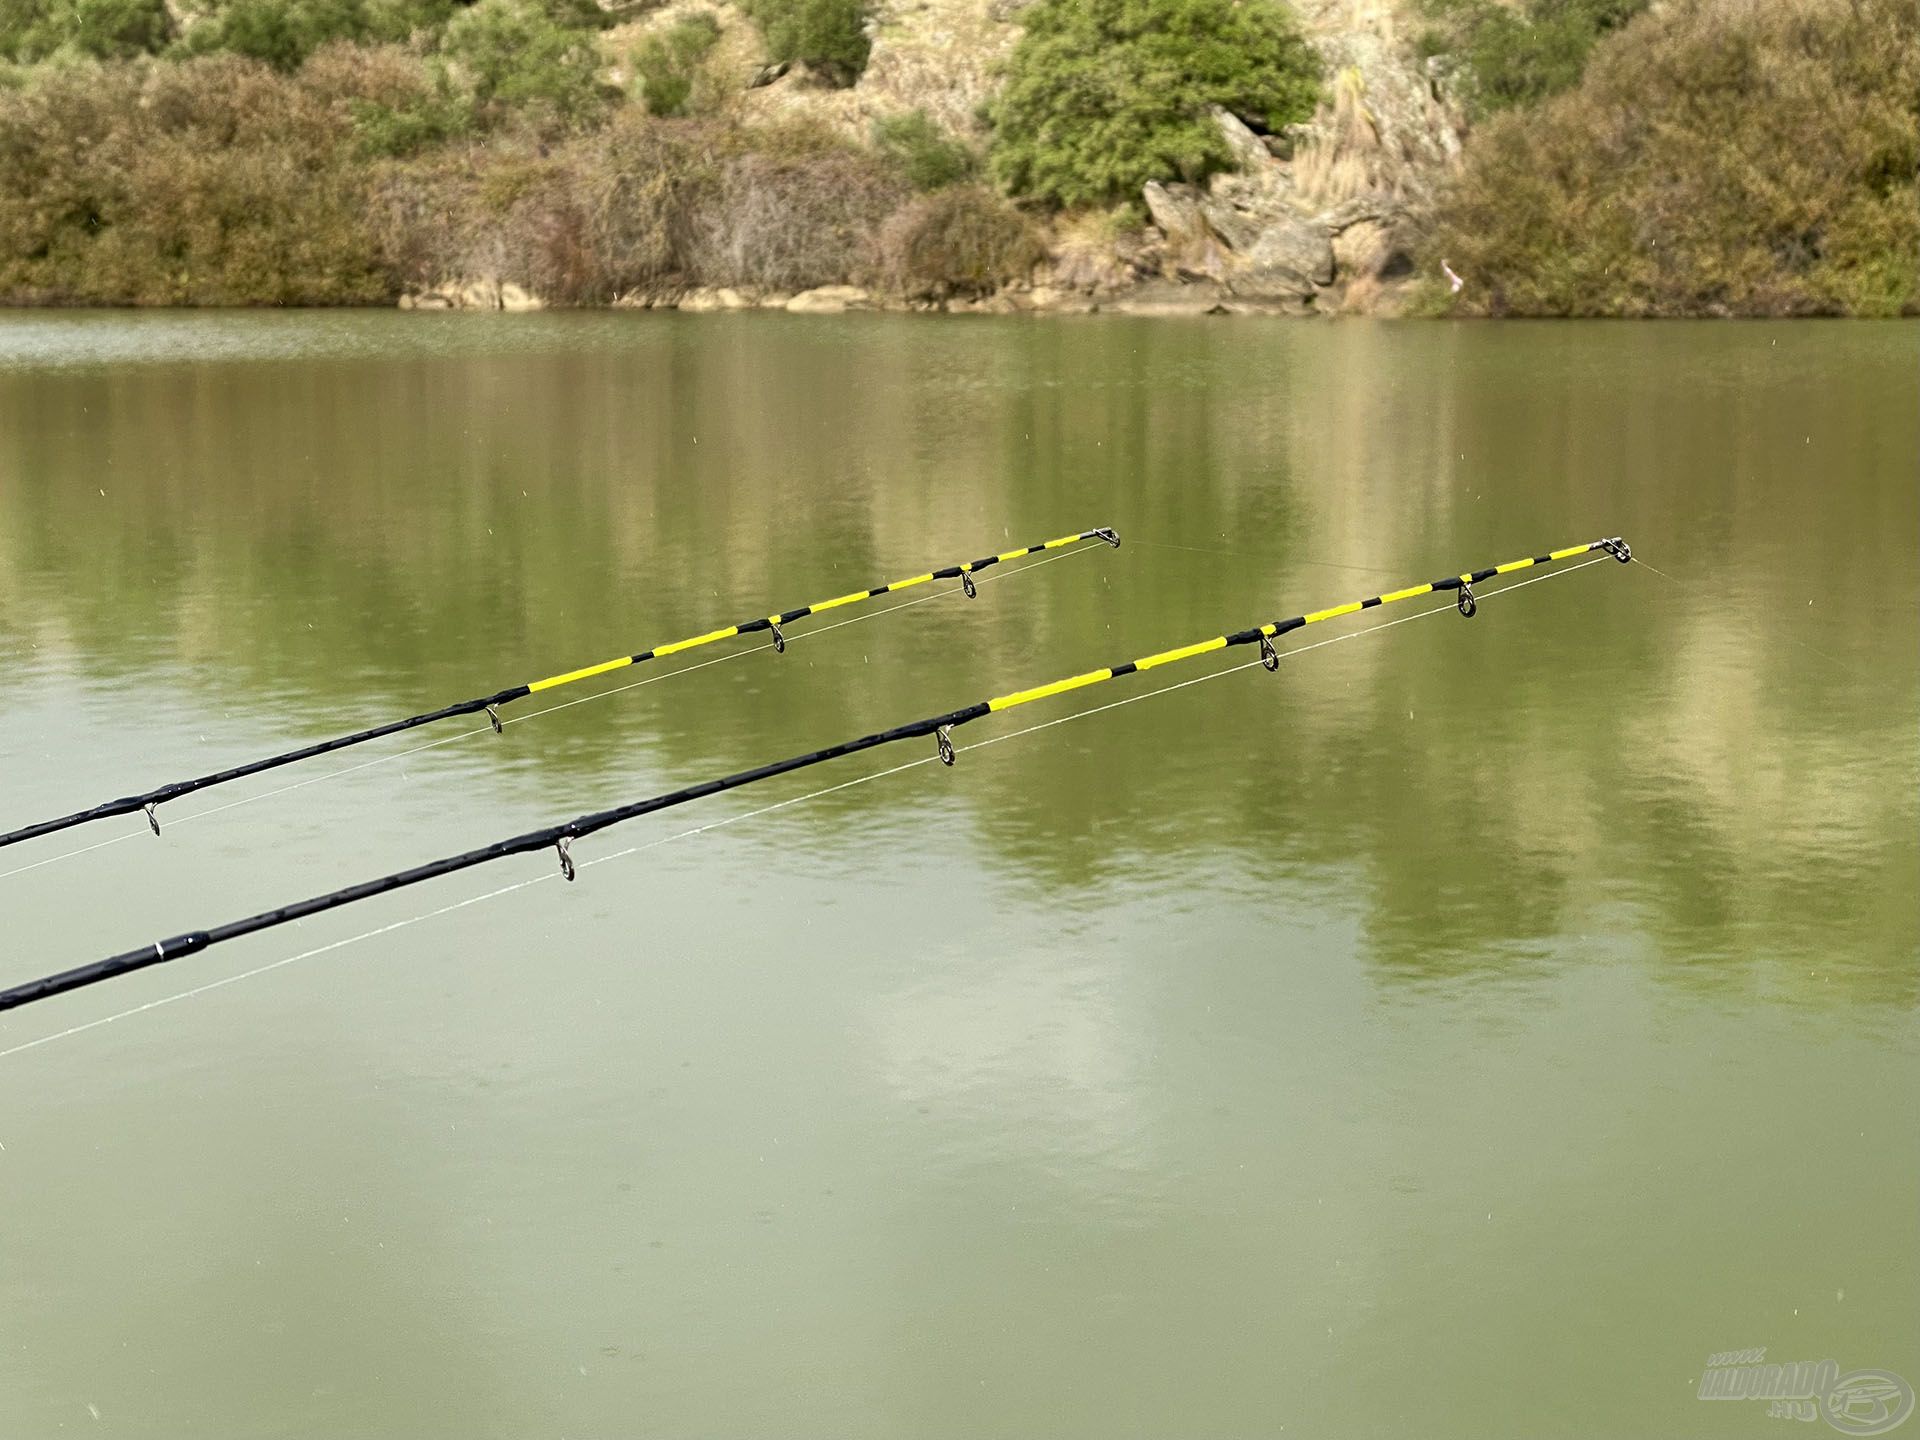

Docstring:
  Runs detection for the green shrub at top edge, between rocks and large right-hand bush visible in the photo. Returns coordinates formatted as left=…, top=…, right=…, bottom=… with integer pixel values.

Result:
left=1419, top=0, right=1647, bottom=115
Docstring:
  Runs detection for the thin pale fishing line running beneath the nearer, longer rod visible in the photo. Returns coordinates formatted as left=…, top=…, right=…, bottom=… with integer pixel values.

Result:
left=0, top=555, right=1607, bottom=1060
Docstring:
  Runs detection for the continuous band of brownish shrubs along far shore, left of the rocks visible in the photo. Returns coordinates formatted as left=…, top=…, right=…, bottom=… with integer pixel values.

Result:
left=0, top=38, right=1041, bottom=305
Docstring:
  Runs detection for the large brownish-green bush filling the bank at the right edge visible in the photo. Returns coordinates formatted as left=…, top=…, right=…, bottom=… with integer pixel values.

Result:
left=1425, top=0, right=1920, bottom=315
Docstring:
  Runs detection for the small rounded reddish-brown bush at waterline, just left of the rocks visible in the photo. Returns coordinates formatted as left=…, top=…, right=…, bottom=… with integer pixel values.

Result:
left=879, top=184, right=1046, bottom=300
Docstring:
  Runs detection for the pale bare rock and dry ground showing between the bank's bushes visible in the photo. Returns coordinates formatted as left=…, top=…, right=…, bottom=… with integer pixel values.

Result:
left=403, top=0, right=1463, bottom=315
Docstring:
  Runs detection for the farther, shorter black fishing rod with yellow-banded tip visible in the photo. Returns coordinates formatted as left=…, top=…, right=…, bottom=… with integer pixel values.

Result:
left=0, top=526, right=1119, bottom=849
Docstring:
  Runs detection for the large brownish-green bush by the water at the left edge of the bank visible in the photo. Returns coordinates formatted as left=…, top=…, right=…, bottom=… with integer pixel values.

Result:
left=0, top=56, right=394, bottom=305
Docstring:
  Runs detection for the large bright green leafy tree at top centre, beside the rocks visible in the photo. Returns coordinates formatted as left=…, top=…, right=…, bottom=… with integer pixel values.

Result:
left=989, top=0, right=1319, bottom=207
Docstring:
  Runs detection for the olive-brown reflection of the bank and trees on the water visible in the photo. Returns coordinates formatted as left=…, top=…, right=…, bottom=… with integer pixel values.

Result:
left=0, top=317, right=1920, bottom=1004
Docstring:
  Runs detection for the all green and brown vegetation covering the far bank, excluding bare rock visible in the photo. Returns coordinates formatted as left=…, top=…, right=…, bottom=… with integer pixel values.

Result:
left=0, top=0, right=1920, bottom=315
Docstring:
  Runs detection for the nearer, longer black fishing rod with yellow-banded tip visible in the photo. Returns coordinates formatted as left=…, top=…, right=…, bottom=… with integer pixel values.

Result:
left=0, top=536, right=1634, bottom=1010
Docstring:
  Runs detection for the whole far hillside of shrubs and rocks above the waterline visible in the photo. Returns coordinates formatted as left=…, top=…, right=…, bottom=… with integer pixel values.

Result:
left=0, top=0, right=1920, bottom=315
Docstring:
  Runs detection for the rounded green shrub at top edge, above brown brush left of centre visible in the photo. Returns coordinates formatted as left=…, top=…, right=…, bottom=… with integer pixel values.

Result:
left=440, top=0, right=607, bottom=125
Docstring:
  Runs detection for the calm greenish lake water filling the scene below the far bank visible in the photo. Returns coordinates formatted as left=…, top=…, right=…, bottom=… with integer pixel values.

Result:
left=0, top=313, right=1920, bottom=1440
